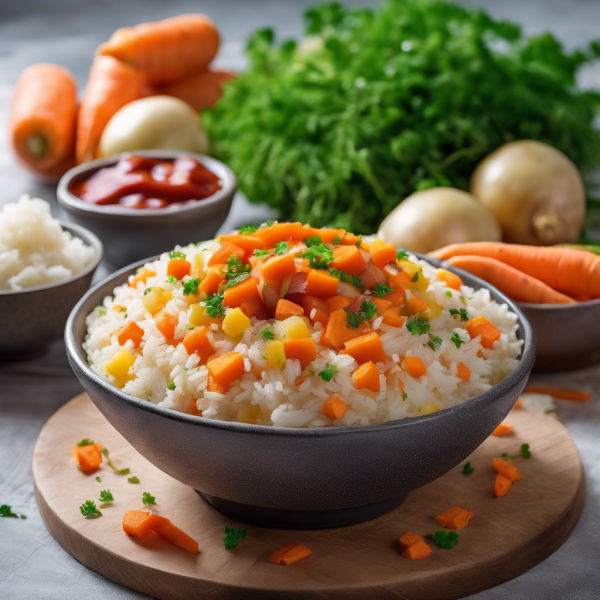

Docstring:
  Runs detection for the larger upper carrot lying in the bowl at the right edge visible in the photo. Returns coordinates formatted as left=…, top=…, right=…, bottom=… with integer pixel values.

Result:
left=432, top=242, right=600, bottom=298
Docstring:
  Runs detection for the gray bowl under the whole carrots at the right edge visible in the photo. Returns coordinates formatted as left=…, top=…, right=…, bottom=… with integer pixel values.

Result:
left=519, top=299, right=600, bottom=371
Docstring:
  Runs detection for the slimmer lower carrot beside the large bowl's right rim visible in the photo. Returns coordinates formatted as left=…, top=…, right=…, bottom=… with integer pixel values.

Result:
left=446, top=256, right=575, bottom=304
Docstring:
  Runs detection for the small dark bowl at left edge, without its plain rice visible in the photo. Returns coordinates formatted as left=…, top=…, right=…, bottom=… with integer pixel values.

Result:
left=0, top=221, right=102, bottom=360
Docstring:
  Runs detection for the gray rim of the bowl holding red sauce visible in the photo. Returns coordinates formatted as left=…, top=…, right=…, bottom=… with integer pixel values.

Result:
left=56, top=149, right=237, bottom=220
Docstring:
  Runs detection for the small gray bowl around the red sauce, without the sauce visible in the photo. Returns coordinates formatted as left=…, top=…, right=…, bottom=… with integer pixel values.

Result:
left=57, top=150, right=237, bottom=268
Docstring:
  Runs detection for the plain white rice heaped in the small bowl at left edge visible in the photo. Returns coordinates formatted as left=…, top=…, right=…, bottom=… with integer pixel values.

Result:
left=0, top=195, right=94, bottom=291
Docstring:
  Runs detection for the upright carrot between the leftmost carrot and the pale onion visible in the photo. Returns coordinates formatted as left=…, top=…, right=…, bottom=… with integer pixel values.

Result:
left=76, top=56, right=147, bottom=163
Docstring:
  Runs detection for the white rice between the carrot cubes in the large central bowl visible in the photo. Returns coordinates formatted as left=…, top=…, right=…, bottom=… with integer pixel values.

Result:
left=84, top=241, right=522, bottom=428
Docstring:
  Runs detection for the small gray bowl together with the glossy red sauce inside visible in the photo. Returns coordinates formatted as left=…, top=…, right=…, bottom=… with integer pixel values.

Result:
left=57, top=150, right=237, bottom=268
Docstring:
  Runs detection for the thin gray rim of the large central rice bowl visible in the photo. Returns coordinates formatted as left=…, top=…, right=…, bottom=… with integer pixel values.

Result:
left=65, top=253, right=536, bottom=438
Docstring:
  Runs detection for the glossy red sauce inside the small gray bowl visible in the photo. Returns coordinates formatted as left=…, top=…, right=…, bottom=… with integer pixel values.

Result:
left=69, top=156, right=222, bottom=209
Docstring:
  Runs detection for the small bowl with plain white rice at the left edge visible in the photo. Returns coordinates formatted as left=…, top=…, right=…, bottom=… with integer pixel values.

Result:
left=0, top=195, right=103, bottom=360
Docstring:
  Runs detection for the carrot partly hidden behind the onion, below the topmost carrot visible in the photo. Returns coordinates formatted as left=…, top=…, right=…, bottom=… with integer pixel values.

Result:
left=153, top=70, right=236, bottom=110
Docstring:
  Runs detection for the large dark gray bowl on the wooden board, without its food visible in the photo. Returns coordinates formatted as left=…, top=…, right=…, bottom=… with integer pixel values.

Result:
left=65, top=259, right=535, bottom=529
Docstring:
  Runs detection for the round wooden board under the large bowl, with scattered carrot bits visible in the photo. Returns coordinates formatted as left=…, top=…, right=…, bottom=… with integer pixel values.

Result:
left=33, top=394, right=585, bottom=600
